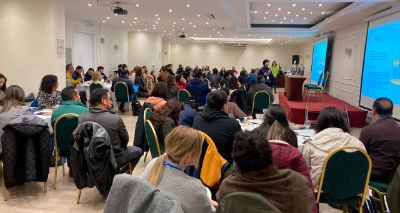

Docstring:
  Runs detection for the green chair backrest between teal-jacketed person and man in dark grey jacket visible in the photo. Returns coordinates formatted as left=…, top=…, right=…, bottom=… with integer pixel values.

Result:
left=54, top=113, right=79, bottom=157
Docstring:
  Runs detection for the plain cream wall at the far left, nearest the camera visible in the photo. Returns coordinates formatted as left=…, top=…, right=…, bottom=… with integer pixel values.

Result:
left=0, top=0, right=65, bottom=95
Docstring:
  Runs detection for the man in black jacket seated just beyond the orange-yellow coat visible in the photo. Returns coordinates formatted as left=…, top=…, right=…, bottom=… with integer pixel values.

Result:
left=193, top=90, right=241, bottom=162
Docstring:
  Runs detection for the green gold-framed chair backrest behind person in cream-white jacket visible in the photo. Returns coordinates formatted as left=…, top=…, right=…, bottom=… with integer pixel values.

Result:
left=317, top=147, right=372, bottom=206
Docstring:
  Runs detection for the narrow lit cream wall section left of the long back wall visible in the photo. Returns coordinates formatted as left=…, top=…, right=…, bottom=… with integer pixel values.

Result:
left=128, top=32, right=162, bottom=70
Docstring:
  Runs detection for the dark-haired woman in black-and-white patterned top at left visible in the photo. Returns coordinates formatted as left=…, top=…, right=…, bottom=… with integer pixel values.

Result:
left=37, top=75, right=62, bottom=109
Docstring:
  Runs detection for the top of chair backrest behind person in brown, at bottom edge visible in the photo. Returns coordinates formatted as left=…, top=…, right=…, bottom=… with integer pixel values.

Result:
left=217, top=192, right=281, bottom=213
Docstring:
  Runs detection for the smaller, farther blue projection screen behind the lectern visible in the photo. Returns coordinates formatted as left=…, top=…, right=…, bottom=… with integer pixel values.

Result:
left=311, top=39, right=328, bottom=84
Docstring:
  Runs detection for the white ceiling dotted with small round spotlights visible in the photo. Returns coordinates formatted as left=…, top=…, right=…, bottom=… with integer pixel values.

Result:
left=65, top=0, right=394, bottom=44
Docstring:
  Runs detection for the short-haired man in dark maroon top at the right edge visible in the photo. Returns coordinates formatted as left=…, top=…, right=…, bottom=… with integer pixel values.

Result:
left=360, top=98, right=400, bottom=183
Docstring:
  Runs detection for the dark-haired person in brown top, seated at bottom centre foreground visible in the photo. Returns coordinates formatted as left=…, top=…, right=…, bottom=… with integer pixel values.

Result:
left=217, top=131, right=315, bottom=213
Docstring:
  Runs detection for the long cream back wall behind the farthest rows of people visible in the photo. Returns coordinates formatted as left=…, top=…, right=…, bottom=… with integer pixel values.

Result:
left=171, top=42, right=300, bottom=71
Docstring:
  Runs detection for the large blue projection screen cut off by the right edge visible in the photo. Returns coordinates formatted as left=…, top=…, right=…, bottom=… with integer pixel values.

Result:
left=361, top=20, right=400, bottom=107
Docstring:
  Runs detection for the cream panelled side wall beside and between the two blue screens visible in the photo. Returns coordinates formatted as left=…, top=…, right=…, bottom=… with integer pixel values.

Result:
left=300, top=23, right=368, bottom=106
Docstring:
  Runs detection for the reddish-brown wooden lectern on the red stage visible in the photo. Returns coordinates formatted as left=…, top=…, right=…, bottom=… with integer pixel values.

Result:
left=285, top=75, right=307, bottom=101
